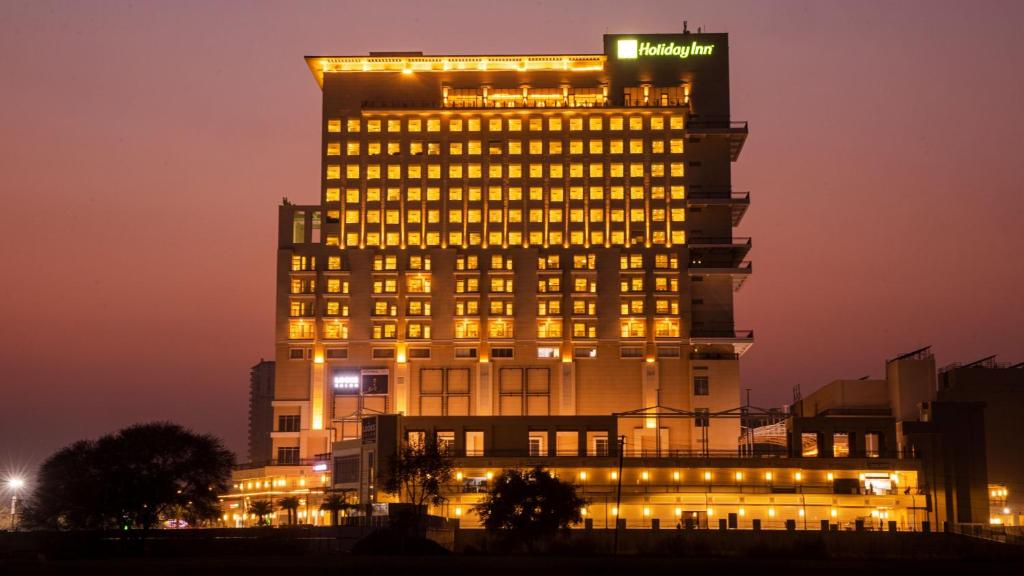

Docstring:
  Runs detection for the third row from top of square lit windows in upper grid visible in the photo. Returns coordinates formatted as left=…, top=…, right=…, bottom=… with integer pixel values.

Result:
left=327, top=162, right=686, bottom=180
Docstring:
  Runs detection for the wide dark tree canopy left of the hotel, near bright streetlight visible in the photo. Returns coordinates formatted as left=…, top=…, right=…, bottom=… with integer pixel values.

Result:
left=24, top=422, right=234, bottom=530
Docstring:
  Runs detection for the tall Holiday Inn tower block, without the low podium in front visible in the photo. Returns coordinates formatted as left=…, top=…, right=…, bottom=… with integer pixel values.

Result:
left=273, top=34, right=753, bottom=462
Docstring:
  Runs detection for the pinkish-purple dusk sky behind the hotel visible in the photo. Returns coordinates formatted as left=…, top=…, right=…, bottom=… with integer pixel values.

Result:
left=0, top=0, right=1024, bottom=472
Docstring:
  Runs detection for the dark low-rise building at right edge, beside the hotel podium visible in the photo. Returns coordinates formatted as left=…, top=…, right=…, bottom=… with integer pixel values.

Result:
left=778, top=347, right=1024, bottom=525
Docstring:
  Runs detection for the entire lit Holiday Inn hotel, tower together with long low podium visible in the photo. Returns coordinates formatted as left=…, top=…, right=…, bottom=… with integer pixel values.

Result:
left=230, top=32, right=950, bottom=529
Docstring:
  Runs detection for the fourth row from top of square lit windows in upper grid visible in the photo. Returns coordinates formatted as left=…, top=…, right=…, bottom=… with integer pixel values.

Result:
left=325, top=186, right=686, bottom=202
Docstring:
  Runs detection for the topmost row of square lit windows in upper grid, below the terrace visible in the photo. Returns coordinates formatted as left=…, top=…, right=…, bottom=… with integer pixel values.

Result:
left=327, top=114, right=685, bottom=133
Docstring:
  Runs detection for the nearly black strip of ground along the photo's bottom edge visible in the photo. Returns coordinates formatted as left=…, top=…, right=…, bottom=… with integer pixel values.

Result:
left=0, top=554, right=1024, bottom=576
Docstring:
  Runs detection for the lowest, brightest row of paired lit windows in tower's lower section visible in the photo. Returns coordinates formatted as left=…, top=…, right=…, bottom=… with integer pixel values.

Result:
left=288, top=318, right=680, bottom=340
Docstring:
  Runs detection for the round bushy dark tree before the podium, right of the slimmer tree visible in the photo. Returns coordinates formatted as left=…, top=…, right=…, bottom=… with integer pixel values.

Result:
left=473, top=466, right=586, bottom=549
